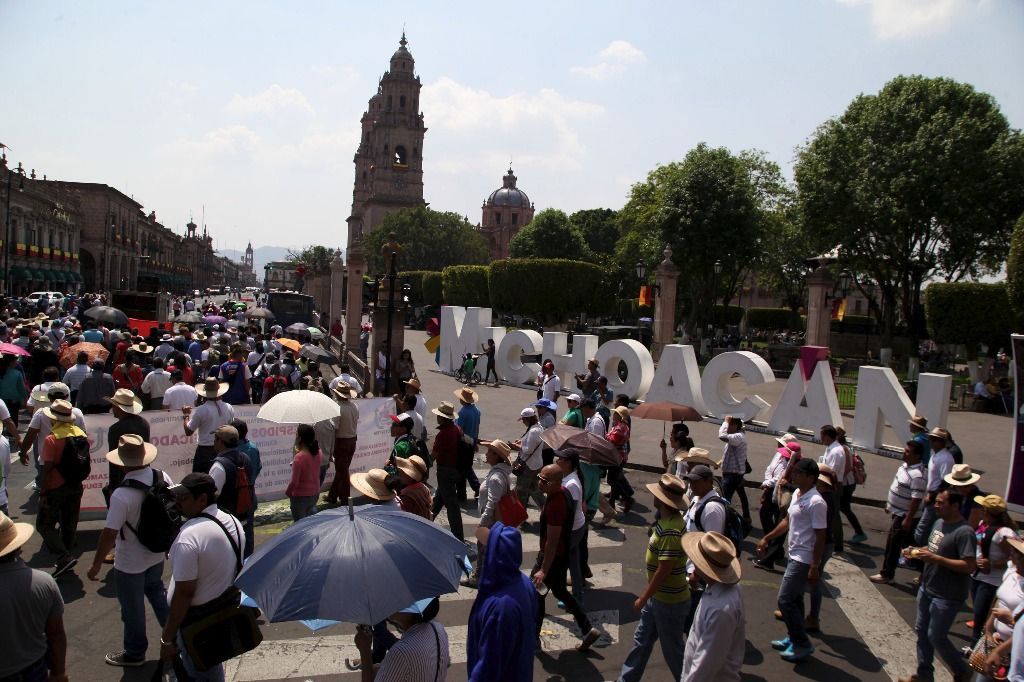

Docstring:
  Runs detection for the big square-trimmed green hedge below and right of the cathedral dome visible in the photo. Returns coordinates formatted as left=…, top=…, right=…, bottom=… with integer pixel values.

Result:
left=488, top=258, right=611, bottom=325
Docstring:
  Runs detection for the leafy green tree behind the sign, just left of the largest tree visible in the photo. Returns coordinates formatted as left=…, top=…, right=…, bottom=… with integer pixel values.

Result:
left=615, top=143, right=784, bottom=336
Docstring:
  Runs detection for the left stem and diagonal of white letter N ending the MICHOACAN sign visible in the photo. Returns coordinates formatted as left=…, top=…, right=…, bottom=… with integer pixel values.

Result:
left=853, top=367, right=917, bottom=449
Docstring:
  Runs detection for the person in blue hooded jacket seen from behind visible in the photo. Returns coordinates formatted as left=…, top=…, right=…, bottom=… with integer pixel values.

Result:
left=466, top=521, right=537, bottom=682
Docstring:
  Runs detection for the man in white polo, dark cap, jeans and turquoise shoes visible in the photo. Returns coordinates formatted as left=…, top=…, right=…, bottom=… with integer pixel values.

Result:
left=758, top=458, right=828, bottom=663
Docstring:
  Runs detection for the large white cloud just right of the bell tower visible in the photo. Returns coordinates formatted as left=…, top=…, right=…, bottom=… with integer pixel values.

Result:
left=421, top=77, right=604, bottom=175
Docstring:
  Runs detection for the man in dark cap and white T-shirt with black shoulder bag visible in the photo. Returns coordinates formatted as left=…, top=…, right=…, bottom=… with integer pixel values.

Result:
left=160, top=473, right=245, bottom=680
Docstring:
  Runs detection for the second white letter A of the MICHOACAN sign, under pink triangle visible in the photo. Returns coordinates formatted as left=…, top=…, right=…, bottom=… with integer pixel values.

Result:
left=768, top=359, right=843, bottom=433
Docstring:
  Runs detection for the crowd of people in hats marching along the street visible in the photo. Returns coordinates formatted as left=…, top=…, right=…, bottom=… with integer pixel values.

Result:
left=0, top=298, right=1024, bottom=682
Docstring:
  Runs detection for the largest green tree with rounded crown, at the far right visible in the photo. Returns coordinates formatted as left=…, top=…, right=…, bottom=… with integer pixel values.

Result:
left=795, top=76, right=1024, bottom=354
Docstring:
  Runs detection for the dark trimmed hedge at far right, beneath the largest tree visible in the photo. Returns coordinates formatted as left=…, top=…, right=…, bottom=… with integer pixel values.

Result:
left=924, top=282, right=1018, bottom=359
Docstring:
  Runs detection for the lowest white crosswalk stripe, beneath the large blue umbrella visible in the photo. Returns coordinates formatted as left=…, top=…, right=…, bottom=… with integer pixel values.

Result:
left=224, top=598, right=618, bottom=682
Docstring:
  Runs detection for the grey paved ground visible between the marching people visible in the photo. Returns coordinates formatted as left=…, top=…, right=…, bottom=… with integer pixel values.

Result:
left=10, top=332, right=1011, bottom=682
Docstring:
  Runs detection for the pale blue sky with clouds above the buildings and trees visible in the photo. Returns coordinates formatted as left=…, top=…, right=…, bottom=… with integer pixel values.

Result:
left=0, top=0, right=1024, bottom=249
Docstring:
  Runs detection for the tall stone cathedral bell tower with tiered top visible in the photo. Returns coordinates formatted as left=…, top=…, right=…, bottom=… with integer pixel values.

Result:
left=348, top=32, right=427, bottom=247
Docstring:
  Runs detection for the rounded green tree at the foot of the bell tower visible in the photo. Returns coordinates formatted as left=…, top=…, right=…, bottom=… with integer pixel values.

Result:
left=361, top=208, right=488, bottom=272
